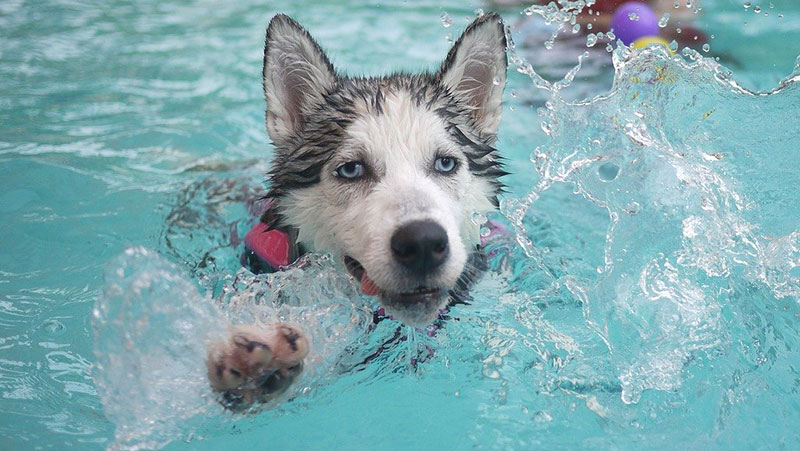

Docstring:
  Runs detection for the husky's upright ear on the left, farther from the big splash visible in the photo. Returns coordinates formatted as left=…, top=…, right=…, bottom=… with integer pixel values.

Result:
left=263, top=14, right=336, bottom=145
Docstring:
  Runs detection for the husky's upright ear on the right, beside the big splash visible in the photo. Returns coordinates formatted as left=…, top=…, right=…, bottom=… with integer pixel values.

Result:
left=437, top=13, right=508, bottom=138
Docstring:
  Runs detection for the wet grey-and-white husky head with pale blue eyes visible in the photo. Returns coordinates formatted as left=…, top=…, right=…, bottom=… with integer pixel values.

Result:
left=263, top=14, right=507, bottom=326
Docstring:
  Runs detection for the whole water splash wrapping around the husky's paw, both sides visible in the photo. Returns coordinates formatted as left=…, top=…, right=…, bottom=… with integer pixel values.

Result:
left=92, top=248, right=372, bottom=449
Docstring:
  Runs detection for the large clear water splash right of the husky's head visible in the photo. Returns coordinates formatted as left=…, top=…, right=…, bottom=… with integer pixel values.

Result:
left=501, top=47, right=800, bottom=403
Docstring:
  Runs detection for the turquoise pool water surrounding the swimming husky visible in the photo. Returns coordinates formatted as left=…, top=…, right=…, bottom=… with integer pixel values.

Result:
left=0, top=0, right=800, bottom=449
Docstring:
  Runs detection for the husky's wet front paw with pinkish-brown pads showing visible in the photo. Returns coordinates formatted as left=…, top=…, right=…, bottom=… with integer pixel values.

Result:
left=207, top=323, right=309, bottom=410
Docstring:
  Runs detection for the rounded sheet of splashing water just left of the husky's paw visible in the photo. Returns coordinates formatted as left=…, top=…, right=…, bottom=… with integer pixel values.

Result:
left=92, top=249, right=225, bottom=448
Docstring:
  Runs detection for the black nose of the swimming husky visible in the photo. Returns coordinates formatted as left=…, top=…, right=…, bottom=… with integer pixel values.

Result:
left=391, top=221, right=450, bottom=276
